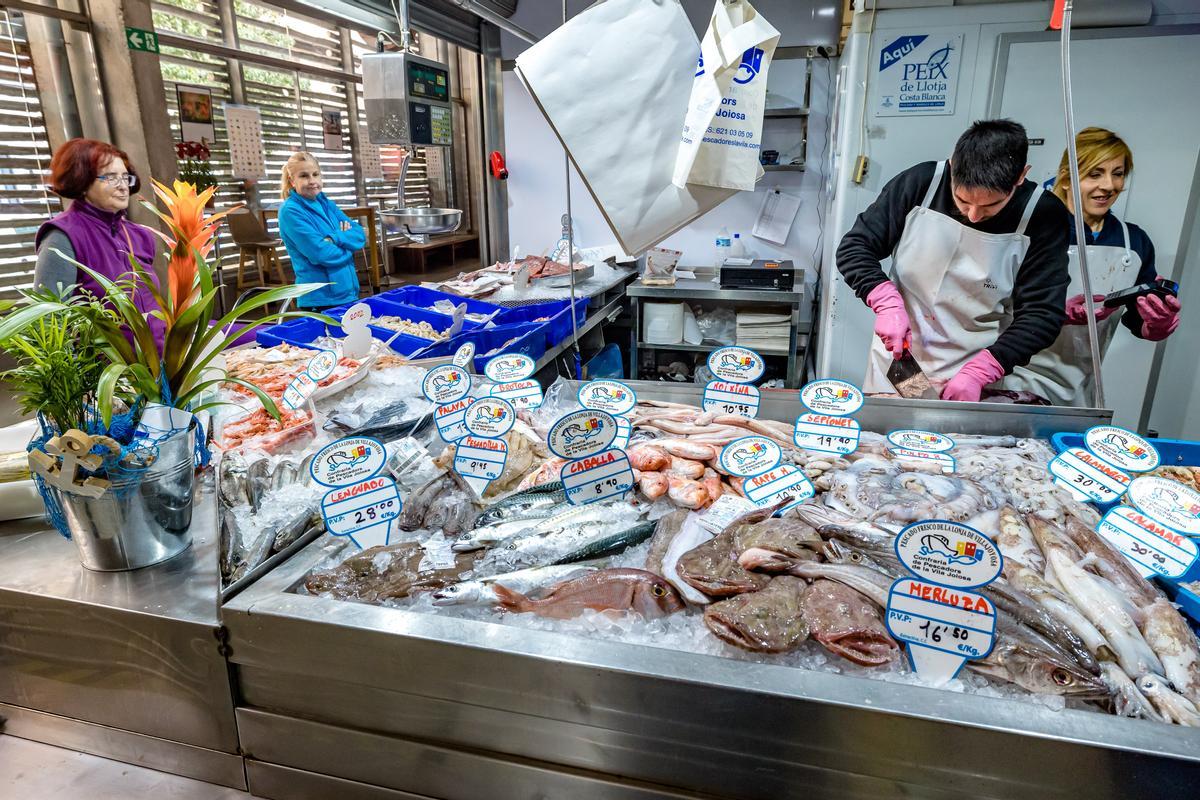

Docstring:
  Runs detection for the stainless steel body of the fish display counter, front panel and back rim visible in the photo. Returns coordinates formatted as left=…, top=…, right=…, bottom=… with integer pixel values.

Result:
left=222, top=383, right=1200, bottom=800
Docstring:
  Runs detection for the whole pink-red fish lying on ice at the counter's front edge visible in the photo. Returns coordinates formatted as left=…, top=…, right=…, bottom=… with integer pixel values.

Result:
left=493, top=570, right=684, bottom=619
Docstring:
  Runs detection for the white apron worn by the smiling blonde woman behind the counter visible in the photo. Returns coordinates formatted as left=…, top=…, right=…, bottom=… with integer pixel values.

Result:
left=1002, top=221, right=1141, bottom=407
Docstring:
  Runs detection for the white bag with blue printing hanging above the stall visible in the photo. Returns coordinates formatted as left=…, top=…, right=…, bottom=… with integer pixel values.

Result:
left=672, top=0, right=779, bottom=191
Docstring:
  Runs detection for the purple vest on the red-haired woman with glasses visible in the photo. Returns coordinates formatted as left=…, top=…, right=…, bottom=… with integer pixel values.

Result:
left=35, top=199, right=166, bottom=354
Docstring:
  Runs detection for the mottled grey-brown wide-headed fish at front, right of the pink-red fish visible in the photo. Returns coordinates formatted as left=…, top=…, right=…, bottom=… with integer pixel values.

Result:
left=704, top=575, right=809, bottom=652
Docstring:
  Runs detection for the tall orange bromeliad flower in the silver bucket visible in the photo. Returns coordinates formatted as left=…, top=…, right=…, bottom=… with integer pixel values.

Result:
left=145, top=181, right=238, bottom=325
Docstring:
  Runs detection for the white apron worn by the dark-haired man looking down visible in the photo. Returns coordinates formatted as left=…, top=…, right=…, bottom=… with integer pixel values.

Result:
left=863, top=161, right=1043, bottom=393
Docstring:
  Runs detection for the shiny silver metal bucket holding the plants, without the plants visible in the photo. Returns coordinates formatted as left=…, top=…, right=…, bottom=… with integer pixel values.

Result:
left=50, top=426, right=196, bottom=572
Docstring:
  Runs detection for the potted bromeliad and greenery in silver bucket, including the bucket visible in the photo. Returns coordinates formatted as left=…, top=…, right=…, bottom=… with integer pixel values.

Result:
left=0, top=181, right=322, bottom=570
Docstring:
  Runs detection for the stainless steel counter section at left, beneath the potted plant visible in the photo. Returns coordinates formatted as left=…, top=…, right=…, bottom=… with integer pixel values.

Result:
left=0, top=480, right=246, bottom=788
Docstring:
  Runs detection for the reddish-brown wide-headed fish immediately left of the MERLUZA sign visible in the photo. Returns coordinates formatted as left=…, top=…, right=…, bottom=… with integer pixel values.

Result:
left=800, top=579, right=900, bottom=667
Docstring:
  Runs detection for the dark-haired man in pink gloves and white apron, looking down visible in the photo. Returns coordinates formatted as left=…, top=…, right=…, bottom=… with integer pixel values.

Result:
left=838, top=120, right=1069, bottom=402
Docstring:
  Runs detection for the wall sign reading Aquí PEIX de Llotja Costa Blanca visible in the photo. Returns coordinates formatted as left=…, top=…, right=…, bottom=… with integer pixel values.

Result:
left=871, top=32, right=962, bottom=116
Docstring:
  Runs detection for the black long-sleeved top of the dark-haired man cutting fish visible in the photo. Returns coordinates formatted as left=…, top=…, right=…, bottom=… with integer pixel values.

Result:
left=836, top=161, right=1070, bottom=373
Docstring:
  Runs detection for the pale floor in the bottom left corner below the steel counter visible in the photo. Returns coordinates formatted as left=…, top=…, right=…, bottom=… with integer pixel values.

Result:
left=0, top=735, right=252, bottom=800
